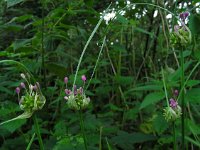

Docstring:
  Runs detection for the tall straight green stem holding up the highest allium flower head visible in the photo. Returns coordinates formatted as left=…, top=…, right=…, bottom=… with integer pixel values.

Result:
left=180, top=48, right=185, bottom=150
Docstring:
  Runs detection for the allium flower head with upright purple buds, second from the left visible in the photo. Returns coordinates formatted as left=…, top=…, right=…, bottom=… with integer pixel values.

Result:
left=64, top=76, right=90, bottom=110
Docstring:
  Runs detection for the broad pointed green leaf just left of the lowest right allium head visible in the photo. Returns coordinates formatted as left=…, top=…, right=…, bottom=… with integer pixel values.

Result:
left=140, top=92, right=165, bottom=109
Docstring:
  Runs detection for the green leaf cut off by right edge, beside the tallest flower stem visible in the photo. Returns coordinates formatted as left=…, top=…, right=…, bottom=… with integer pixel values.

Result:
left=185, top=88, right=200, bottom=104
